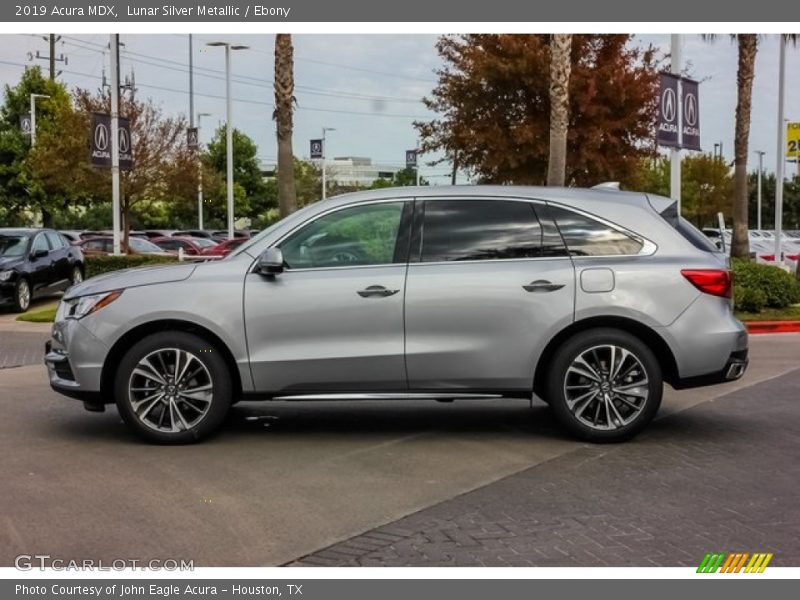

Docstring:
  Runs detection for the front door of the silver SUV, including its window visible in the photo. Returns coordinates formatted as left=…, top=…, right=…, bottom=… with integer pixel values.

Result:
left=245, top=201, right=413, bottom=394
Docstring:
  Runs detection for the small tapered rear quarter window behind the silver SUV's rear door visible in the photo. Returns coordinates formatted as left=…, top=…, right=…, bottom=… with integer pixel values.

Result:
left=548, top=206, right=643, bottom=256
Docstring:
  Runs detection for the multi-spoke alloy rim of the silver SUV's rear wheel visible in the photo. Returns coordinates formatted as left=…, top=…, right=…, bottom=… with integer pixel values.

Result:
left=564, top=344, right=650, bottom=431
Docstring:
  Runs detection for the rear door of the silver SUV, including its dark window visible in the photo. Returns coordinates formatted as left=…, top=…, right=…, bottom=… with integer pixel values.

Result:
left=405, top=198, right=575, bottom=393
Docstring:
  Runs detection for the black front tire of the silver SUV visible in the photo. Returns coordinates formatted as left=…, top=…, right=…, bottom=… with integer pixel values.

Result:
left=114, top=331, right=233, bottom=444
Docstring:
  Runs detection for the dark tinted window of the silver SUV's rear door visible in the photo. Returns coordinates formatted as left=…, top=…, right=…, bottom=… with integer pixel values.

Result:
left=421, top=200, right=563, bottom=262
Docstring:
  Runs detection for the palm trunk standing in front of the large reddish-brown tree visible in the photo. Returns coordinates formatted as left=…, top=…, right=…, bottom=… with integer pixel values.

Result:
left=547, top=33, right=572, bottom=185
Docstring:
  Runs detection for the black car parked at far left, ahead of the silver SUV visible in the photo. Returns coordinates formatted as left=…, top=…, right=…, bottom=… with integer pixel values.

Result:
left=0, top=229, right=84, bottom=312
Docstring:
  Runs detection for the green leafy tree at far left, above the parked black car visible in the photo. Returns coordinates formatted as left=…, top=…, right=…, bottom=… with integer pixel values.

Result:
left=0, top=67, right=72, bottom=226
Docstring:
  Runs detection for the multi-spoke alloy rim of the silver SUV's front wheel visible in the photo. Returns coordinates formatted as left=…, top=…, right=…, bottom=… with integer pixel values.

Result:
left=128, top=348, right=214, bottom=433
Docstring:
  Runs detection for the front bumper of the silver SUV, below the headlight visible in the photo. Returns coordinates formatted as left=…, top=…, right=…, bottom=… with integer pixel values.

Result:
left=44, top=319, right=108, bottom=403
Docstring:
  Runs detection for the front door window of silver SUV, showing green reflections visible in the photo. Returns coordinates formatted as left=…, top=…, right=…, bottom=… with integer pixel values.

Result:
left=280, top=202, right=404, bottom=269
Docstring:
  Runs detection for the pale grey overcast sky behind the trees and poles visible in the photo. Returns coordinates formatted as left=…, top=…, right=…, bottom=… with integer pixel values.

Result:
left=0, top=34, right=800, bottom=184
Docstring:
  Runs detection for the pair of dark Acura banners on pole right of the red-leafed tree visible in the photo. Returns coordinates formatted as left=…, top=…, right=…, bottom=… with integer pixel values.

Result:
left=656, top=73, right=701, bottom=150
